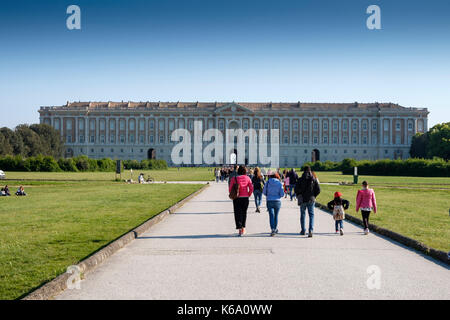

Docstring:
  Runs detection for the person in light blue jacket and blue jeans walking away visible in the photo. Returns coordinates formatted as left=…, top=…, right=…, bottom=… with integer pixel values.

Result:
left=263, top=171, right=284, bottom=237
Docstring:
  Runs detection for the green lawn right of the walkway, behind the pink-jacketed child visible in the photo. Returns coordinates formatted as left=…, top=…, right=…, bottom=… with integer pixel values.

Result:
left=317, top=185, right=450, bottom=252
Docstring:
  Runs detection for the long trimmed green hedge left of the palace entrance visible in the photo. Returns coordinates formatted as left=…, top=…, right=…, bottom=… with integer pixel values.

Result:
left=0, top=155, right=167, bottom=172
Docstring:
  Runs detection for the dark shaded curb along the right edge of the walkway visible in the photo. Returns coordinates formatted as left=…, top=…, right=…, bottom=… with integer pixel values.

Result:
left=316, top=202, right=450, bottom=265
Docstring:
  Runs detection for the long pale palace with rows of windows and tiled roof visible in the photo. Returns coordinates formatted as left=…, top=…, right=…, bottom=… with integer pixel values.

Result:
left=39, top=102, right=429, bottom=167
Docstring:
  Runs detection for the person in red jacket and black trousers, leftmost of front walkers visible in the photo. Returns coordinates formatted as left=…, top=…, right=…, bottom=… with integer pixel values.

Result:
left=228, top=166, right=253, bottom=236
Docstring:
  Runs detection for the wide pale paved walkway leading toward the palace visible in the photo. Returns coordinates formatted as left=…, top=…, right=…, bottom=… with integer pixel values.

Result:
left=56, top=183, right=450, bottom=299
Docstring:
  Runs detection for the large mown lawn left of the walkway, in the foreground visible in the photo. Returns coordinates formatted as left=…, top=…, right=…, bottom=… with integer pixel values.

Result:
left=0, top=181, right=201, bottom=299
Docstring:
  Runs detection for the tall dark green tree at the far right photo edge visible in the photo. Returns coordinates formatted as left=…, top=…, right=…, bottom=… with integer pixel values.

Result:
left=427, top=122, right=450, bottom=160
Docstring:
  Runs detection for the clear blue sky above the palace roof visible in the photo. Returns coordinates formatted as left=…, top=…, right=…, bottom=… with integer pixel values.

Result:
left=0, top=0, right=450, bottom=127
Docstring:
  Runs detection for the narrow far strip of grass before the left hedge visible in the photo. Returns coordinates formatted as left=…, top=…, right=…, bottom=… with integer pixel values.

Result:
left=0, top=168, right=214, bottom=184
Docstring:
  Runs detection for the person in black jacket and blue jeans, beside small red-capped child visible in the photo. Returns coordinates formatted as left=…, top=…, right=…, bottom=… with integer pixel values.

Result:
left=294, top=166, right=320, bottom=238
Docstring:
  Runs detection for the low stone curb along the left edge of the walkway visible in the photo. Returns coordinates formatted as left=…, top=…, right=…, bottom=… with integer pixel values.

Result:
left=21, top=182, right=210, bottom=300
